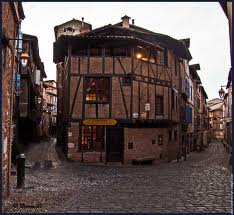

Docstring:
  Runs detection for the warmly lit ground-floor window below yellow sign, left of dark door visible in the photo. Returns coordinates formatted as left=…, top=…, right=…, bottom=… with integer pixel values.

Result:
left=80, top=126, right=104, bottom=151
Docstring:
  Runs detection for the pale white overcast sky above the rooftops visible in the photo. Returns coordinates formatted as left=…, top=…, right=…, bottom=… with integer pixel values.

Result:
left=22, top=2, right=231, bottom=99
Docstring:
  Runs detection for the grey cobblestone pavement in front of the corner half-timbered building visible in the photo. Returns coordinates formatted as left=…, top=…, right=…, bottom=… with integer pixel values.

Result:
left=3, top=143, right=232, bottom=213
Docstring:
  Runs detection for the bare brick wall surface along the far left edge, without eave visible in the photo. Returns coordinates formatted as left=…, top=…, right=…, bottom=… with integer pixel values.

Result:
left=2, top=2, right=17, bottom=199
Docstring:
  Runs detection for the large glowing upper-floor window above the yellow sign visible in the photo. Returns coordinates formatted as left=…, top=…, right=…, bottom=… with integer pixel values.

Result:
left=85, top=78, right=110, bottom=103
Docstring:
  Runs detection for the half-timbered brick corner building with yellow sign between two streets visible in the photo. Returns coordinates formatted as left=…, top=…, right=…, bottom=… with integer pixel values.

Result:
left=54, top=16, right=191, bottom=163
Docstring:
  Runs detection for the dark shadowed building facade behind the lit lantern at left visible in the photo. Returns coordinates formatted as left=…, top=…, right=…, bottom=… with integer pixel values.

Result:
left=19, top=34, right=46, bottom=145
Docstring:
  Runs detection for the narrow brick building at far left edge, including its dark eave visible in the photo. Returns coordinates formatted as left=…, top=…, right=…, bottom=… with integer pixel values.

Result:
left=1, top=2, right=25, bottom=200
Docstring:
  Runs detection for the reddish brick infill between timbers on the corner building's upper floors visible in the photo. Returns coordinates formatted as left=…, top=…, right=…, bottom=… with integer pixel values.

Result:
left=69, top=52, right=179, bottom=121
